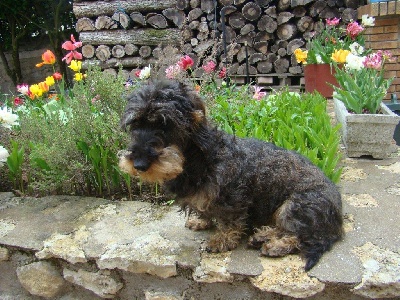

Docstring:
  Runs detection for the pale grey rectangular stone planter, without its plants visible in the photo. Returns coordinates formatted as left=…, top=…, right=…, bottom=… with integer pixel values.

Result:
left=333, top=99, right=400, bottom=159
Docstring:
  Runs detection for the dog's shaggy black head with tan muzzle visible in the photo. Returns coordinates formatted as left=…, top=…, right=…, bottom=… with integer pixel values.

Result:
left=119, top=80, right=207, bottom=182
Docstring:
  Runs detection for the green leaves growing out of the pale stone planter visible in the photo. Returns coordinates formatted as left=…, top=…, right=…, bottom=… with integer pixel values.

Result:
left=333, top=66, right=393, bottom=114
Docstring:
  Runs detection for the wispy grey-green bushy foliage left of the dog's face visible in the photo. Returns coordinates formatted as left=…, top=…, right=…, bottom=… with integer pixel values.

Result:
left=4, top=69, right=131, bottom=196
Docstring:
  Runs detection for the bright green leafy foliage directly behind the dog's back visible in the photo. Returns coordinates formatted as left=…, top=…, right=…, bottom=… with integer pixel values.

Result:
left=206, top=86, right=341, bottom=182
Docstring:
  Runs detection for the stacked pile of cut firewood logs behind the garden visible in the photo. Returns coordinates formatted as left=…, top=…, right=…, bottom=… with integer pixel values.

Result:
left=73, top=0, right=359, bottom=82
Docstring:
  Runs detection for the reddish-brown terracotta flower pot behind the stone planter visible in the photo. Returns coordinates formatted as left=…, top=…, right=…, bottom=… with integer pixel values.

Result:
left=304, top=64, right=338, bottom=98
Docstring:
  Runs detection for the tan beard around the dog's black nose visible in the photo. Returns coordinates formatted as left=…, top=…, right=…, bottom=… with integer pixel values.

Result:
left=118, top=146, right=184, bottom=183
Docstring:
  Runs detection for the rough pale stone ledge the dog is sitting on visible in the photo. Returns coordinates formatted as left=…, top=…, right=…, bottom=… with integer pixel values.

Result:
left=0, top=163, right=400, bottom=300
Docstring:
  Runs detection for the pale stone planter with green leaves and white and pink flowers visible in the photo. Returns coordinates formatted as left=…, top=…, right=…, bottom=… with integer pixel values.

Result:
left=333, top=50, right=400, bottom=159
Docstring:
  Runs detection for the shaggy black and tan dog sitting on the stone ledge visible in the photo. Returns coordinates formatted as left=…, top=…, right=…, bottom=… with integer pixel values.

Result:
left=119, top=80, right=342, bottom=270
